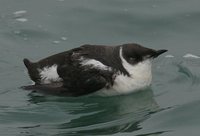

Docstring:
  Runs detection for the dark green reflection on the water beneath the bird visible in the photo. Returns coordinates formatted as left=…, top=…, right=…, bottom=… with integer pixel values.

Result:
left=25, top=89, right=159, bottom=135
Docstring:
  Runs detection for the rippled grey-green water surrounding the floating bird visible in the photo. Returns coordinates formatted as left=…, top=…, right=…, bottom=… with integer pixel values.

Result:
left=0, top=0, right=200, bottom=136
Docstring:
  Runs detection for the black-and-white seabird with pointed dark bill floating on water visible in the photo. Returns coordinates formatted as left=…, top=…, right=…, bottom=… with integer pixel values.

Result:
left=24, top=43, right=167, bottom=96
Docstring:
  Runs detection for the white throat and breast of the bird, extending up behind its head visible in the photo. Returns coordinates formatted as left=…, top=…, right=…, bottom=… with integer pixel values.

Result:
left=97, top=48, right=152, bottom=96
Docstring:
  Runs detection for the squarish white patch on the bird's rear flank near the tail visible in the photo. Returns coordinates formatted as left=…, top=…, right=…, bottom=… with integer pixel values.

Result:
left=38, top=65, right=62, bottom=84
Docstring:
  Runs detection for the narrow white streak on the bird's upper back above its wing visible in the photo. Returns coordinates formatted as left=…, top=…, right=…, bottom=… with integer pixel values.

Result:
left=80, top=57, right=111, bottom=70
